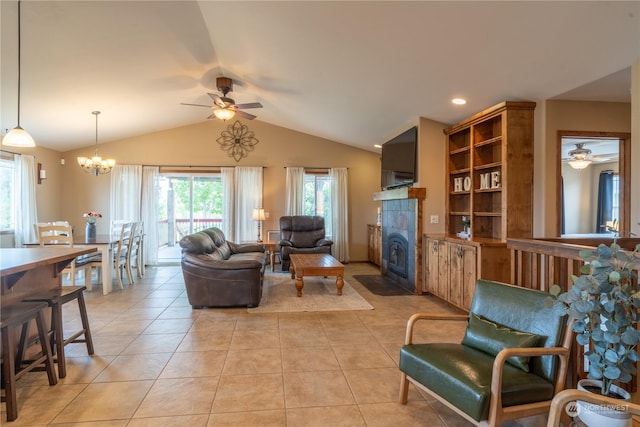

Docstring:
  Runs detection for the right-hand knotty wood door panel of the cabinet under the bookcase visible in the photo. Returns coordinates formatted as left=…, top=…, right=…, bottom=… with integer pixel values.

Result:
left=449, top=243, right=477, bottom=310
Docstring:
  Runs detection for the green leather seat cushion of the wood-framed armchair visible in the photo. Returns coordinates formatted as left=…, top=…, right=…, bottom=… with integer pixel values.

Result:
left=400, top=343, right=553, bottom=421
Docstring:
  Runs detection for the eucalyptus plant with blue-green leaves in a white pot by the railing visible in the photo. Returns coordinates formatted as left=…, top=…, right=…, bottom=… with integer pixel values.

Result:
left=550, top=239, right=640, bottom=425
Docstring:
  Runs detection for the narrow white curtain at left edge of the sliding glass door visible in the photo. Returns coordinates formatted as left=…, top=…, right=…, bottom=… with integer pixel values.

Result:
left=140, top=166, right=159, bottom=265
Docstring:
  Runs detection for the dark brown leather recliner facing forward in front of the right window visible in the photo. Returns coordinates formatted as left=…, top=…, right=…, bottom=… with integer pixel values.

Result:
left=278, top=216, right=333, bottom=271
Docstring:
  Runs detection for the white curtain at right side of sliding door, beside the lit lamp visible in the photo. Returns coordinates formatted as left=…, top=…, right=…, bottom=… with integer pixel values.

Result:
left=233, top=167, right=262, bottom=243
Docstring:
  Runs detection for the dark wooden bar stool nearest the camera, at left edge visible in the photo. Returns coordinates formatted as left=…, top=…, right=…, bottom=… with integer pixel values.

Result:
left=0, top=302, right=58, bottom=421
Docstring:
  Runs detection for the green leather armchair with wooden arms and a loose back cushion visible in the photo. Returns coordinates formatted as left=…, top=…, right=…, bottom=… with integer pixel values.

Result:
left=399, top=280, right=572, bottom=426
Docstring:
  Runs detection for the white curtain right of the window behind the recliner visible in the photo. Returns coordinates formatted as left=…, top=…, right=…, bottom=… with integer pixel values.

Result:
left=329, top=168, right=349, bottom=262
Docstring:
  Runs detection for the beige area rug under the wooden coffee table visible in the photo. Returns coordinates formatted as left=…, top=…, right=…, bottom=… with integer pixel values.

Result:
left=247, top=271, right=373, bottom=313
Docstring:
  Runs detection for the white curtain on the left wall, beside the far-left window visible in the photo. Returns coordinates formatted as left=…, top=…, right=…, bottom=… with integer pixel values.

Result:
left=13, top=154, right=38, bottom=248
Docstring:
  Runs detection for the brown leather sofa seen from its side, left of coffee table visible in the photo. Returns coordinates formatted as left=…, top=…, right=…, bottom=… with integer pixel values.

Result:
left=180, top=227, right=267, bottom=308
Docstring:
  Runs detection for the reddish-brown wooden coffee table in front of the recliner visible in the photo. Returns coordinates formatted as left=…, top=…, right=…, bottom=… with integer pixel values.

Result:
left=289, top=254, right=344, bottom=297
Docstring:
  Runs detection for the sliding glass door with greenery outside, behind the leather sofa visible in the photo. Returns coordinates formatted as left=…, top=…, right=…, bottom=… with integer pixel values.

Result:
left=156, top=173, right=224, bottom=263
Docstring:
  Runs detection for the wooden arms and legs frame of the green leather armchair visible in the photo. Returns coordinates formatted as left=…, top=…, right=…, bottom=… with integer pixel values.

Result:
left=400, top=313, right=573, bottom=426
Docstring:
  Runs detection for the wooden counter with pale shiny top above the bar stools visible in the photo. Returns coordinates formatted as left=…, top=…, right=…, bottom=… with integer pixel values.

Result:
left=0, top=247, right=96, bottom=306
